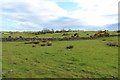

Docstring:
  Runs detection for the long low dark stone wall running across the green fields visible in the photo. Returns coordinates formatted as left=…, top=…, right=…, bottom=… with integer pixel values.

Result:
left=0, top=35, right=120, bottom=41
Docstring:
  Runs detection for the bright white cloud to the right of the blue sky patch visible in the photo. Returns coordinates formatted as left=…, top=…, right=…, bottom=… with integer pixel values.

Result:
left=69, top=0, right=118, bottom=26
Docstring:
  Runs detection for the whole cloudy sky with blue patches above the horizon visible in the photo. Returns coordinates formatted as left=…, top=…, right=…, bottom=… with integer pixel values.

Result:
left=0, top=0, right=119, bottom=31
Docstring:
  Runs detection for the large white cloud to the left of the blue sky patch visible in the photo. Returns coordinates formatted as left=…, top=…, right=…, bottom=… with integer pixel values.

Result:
left=0, top=0, right=67, bottom=28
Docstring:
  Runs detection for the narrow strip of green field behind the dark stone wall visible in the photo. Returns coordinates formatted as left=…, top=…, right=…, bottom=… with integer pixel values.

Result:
left=2, top=31, right=118, bottom=38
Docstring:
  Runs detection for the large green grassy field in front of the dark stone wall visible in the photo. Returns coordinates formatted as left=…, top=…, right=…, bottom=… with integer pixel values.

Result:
left=2, top=36, right=118, bottom=78
